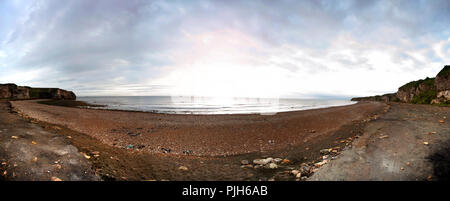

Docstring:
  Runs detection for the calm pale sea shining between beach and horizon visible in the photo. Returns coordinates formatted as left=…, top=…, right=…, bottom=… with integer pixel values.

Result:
left=77, top=96, right=356, bottom=114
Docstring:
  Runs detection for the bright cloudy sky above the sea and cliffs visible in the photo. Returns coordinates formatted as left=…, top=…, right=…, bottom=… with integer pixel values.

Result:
left=0, top=0, right=450, bottom=98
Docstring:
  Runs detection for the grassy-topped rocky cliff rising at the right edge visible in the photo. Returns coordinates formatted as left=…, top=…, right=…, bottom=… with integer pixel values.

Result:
left=352, top=65, right=450, bottom=105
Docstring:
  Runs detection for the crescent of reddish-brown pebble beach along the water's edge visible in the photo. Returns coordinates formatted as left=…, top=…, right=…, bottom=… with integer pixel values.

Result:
left=11, top=101, right=384, bottom=156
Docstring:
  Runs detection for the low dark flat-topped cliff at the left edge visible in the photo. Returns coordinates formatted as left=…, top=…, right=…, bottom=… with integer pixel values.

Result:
left=0, top=84, right=76, bottom=100
